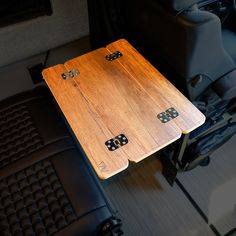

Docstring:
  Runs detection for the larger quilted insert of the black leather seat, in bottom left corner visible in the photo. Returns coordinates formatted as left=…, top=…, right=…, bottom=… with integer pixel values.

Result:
left=0, top=160, right=77, bottom=236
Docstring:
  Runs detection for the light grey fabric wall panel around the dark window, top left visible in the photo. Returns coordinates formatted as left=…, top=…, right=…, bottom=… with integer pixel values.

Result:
left=0, top=0, right=89, bottom=66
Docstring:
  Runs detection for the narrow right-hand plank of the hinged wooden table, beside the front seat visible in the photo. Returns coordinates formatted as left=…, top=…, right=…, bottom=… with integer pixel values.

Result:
left=107, top=39, right=205, bottom=134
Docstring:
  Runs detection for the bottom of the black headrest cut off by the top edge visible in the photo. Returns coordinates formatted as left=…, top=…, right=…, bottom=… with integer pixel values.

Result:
left=159, top=0, right=202, bottom=12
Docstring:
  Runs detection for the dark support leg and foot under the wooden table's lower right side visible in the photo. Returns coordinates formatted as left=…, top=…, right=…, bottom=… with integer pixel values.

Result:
left=161, top=134, right=189, bottom=186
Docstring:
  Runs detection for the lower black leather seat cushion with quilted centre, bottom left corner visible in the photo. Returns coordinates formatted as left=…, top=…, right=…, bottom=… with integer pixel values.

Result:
left=0, top=149, right=112, bottom=236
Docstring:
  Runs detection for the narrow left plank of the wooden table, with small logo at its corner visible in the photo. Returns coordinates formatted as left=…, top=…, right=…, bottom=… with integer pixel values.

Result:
left=43, top=65, right=128, bottom=179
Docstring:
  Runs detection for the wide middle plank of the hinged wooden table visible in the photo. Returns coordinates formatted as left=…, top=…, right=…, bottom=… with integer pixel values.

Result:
left=65, top=48, right=181, bottom=162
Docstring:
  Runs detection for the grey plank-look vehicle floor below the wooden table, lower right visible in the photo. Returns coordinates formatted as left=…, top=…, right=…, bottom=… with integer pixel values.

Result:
left=103, top=135, right=236, bottom=236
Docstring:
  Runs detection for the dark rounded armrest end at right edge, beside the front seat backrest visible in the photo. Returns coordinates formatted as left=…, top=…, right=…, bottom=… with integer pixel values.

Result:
left=212, top=69, right=236, bottom=100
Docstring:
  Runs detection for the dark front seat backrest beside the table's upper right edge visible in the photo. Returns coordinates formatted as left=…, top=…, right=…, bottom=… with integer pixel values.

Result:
left=125, top=0, right=235, bottom=100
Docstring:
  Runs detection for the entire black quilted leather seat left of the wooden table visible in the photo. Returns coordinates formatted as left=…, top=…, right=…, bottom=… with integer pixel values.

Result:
left=0, top=88, right=120, bottom=236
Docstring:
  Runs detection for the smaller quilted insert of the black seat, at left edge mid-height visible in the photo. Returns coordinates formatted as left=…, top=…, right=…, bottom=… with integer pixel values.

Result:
left=0, top=105, right=42, bottom=168
